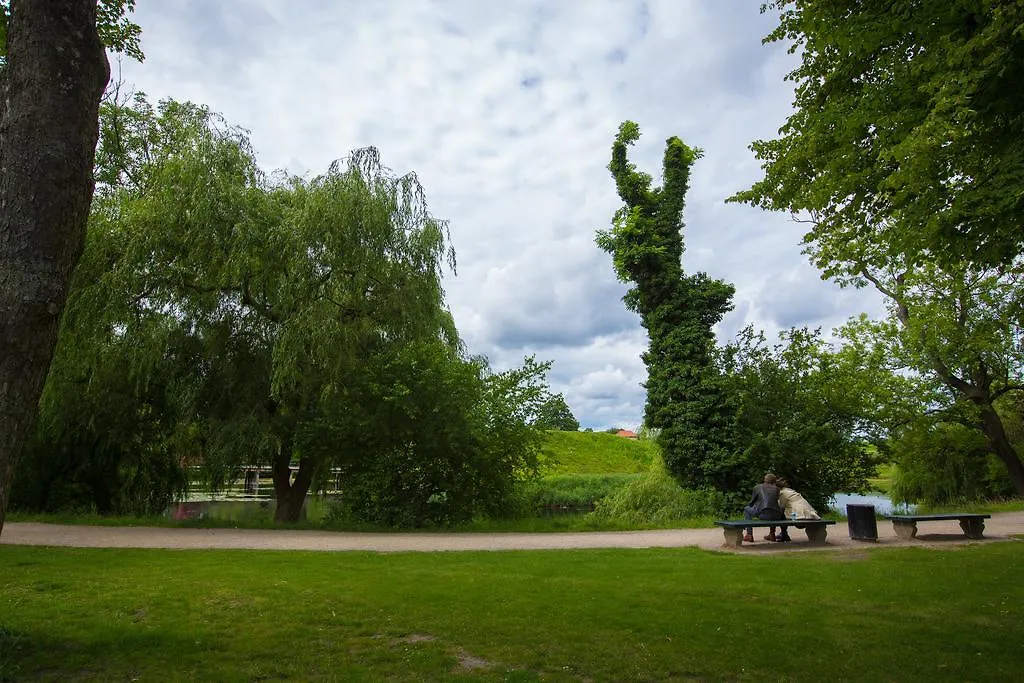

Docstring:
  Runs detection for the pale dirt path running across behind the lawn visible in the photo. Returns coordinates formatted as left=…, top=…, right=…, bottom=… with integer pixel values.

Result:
left=0, top=512, right=1024, bottom=553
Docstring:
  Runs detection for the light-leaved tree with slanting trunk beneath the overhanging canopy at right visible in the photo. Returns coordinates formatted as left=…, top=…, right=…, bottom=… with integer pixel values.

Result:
left=835, top=260, right=1024, bottom=496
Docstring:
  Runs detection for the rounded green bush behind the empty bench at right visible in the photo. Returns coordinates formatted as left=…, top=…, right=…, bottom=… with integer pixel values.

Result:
left=891, top=420, right=1013, bottom=506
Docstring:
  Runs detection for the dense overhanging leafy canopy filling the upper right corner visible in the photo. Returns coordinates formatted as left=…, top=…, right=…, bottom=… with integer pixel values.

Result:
left=733, top=0, right=1024, bottom=275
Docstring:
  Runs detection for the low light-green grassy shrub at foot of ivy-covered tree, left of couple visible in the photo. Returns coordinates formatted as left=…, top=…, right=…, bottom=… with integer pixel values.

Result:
left=592, top=472, right=726, bottom=526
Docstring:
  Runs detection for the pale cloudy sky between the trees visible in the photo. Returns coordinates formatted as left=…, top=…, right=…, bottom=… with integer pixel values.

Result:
left=113, top=0, right=879, bottom=429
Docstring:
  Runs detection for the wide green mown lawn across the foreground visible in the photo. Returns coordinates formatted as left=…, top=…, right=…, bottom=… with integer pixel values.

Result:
left=0, top=542, right=1024, bottom=681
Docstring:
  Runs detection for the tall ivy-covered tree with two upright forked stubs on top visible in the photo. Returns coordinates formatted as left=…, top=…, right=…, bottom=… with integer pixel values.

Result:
left=597, top=121, right=740, bottom=490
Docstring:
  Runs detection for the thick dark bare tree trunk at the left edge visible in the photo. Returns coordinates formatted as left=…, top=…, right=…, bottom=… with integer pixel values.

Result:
left=0, top=0, right=110, bottom=531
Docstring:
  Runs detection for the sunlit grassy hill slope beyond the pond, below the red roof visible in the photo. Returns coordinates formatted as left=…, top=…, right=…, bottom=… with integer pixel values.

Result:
left=542, top=431, right=662, bottom=475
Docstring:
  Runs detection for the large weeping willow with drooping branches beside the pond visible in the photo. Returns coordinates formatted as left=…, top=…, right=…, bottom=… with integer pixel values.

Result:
left=18, top=96, right=459, bottom=521
